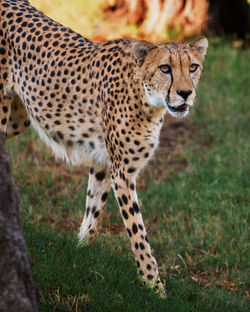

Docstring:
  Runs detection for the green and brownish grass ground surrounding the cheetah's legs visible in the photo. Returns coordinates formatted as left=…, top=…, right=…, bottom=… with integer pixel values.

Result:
left=7, top=39, right=250, bottom=312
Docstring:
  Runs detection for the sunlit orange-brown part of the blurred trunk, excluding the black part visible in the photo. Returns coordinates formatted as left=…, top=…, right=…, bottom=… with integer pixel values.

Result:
left=104, top=0, right=208, bottom=40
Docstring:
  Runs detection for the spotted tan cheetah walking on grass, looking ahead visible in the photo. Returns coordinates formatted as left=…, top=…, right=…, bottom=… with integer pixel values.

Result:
left=0, top=0, right=208, bottom=297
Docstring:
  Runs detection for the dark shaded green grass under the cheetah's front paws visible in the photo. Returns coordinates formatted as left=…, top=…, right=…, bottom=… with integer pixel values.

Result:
left=24, top=223, right=247, bottom=312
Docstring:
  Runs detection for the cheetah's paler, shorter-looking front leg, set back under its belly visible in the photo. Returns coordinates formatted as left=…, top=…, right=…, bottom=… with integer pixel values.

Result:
left=79, top=164, right=110, bottom=242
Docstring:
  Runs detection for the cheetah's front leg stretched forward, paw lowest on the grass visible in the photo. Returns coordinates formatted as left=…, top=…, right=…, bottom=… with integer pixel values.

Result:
left=111, top=170, right=165, bottom=297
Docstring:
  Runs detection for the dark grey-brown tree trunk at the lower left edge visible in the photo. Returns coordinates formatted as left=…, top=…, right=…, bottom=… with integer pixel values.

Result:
left=0, top=131, right=38, bottom=312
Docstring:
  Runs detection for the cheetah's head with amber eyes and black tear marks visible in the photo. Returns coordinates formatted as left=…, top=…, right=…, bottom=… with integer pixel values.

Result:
left=132, top=38, right=208, bottom=117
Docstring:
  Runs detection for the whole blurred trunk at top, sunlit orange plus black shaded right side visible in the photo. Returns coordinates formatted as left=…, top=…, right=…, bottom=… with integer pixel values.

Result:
left=103, top=0, right=250, bottom=40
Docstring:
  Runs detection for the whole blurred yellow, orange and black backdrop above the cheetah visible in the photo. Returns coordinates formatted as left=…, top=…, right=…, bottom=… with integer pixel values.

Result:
left=30, top=0, right=249, bottom=41
